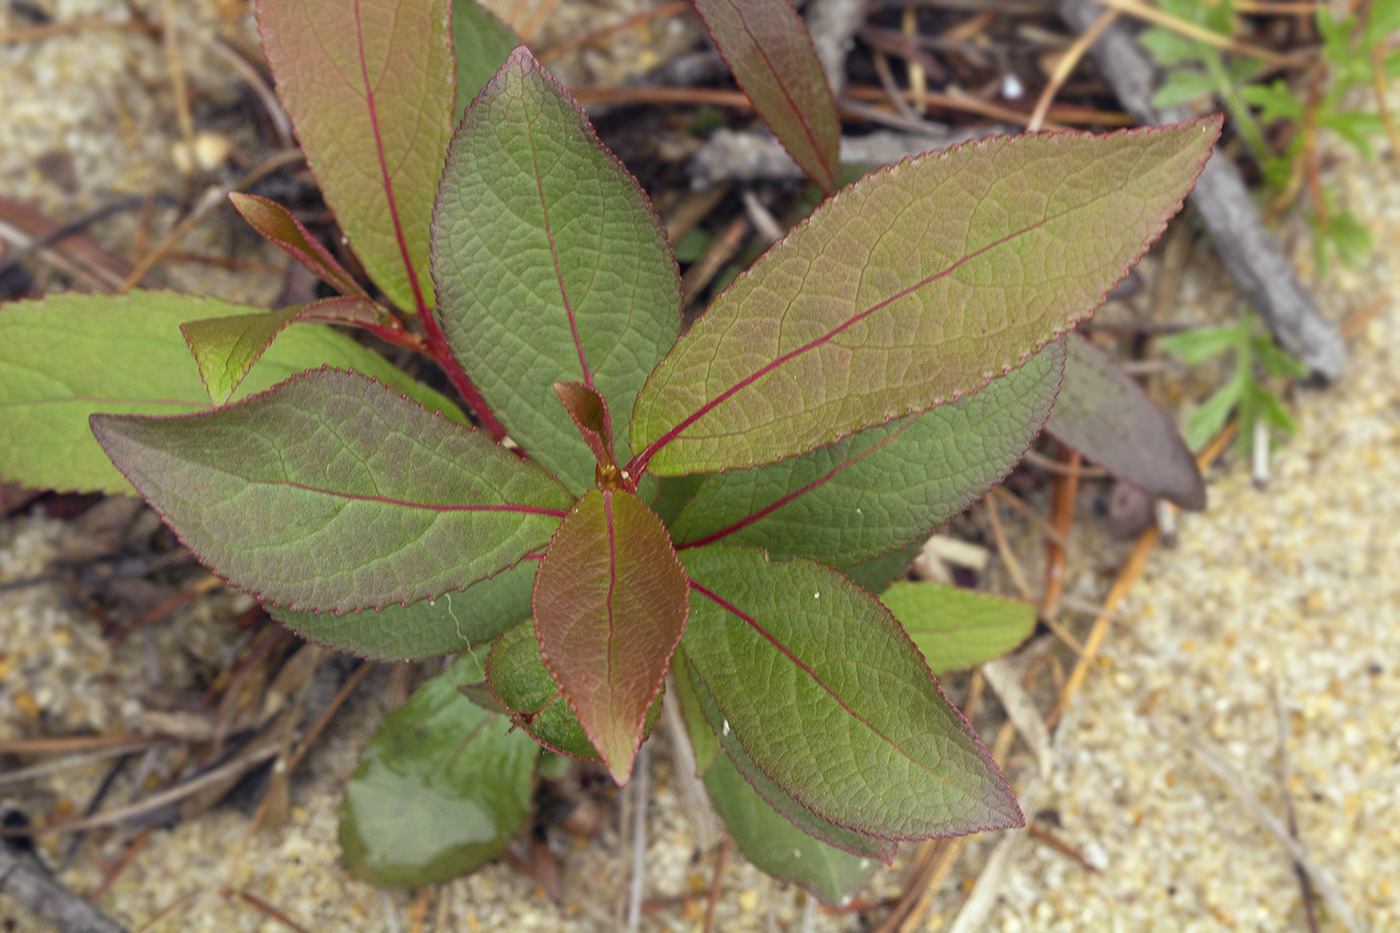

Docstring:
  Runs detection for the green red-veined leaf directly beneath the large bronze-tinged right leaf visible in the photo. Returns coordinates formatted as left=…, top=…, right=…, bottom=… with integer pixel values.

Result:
left=671, top=342, right=1064, bottom=565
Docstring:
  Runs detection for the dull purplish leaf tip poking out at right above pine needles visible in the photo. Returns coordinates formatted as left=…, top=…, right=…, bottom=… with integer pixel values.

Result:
left=1046, top=333, right=1205, bottom=511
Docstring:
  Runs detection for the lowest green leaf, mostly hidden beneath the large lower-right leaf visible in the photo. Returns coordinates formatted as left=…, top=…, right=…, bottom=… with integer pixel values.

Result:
left=704, top=755, right=879, bottom=908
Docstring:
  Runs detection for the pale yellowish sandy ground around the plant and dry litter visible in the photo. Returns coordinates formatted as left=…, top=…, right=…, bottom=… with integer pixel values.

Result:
left=0, top=1, right=1400, bottom=933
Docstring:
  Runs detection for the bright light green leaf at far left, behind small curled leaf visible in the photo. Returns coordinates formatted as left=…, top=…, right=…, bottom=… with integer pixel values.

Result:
left=0, top=291, right=466, bottom=496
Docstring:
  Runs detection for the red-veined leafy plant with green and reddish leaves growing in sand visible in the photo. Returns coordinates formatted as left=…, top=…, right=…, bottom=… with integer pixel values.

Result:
left=0, top=0, right=1219, bottom=902
